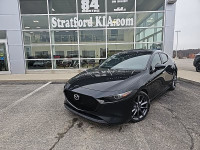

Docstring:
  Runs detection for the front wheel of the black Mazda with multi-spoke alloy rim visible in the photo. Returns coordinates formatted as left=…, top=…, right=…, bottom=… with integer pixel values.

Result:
left=130, top=91, right=150, bottom=123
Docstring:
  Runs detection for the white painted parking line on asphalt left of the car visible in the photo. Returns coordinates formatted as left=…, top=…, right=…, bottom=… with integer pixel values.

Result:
left=0, top=82, right=52, bottom=114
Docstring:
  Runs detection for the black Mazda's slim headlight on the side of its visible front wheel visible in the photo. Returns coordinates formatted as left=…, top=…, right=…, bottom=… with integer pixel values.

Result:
left=97, top=91, right=132, bottom=104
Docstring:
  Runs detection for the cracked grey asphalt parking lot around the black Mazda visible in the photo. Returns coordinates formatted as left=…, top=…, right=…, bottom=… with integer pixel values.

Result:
left=0, top=81, right=200, bottom=150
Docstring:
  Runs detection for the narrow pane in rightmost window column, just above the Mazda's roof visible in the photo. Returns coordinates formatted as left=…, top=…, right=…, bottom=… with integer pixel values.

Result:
left=136, top=43, right=162, bottom=50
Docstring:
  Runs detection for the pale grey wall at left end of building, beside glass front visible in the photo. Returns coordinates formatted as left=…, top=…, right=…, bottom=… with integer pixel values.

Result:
left=0, top=0, right=25, bottom=74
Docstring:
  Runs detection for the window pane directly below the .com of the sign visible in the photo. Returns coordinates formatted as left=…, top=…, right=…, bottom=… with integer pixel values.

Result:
left=107, top=29, right=134, bottom=43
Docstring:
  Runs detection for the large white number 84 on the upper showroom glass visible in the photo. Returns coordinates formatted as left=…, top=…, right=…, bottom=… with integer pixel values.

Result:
left=81, top=0, right=99, bottom=12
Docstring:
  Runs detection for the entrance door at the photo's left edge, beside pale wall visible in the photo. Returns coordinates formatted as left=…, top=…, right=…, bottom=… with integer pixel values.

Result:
left=0, top=40, right=10, bottom=74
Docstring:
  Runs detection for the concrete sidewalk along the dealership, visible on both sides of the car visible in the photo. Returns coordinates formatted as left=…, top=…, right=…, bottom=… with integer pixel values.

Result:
left=0, top=70, right=200, bottom=83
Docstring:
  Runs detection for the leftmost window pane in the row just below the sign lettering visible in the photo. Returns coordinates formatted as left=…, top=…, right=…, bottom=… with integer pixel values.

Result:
left=23, top=31, right=50, bottom=45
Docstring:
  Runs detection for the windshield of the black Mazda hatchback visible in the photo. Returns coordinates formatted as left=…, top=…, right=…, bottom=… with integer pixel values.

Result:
left=99, top=52, right=151, bottom=70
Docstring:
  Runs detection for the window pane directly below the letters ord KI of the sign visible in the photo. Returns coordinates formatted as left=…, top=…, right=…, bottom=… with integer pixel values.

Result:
left=79, top=30, right=106, bottom=43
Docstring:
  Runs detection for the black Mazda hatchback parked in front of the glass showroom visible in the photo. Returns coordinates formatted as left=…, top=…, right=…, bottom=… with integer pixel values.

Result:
left=64, top=50, right=177, bottom=124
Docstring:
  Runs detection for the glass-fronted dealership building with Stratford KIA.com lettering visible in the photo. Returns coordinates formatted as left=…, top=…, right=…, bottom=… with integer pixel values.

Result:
left=0, top=0, right=176, bottom=74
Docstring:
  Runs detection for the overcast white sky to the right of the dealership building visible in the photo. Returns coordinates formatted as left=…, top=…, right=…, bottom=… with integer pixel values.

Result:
left=174, top=0, right=200, bottom=50
